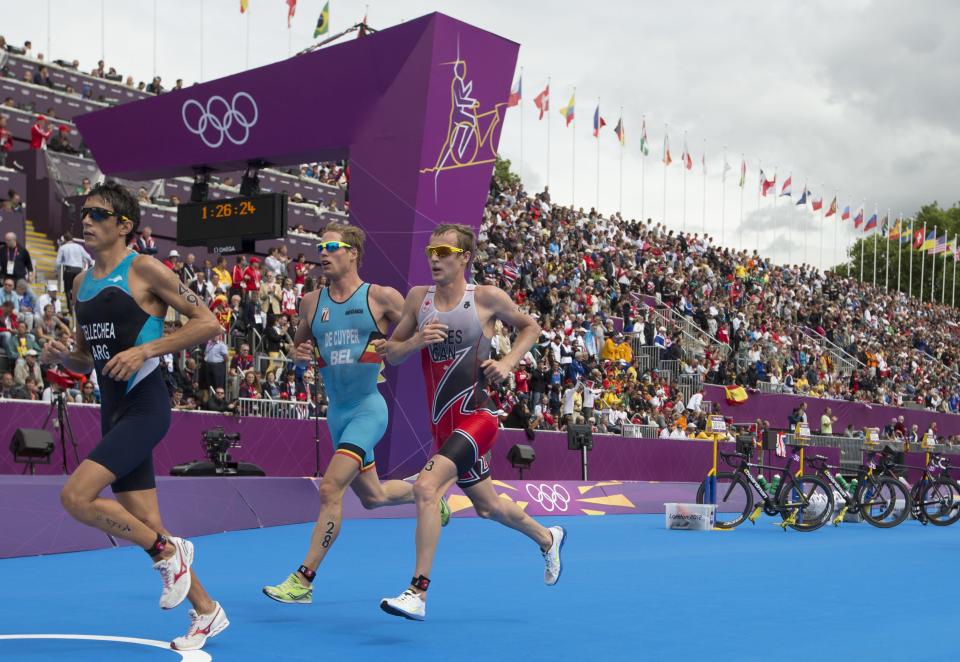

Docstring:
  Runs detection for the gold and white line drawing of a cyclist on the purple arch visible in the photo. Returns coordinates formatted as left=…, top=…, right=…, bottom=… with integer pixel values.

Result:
left=420, top=39, right=507, bottom=196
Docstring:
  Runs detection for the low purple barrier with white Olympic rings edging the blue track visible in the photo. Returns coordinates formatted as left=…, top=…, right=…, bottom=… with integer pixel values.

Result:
left=0, top=476, right=696, bottom=558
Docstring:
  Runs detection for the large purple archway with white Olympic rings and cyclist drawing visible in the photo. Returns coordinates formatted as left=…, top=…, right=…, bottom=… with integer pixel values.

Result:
left=76, top=13, right=519, bottom=476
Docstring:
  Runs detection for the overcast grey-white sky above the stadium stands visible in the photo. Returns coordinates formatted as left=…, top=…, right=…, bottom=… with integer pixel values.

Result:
left=0, top=0, right=960, bottom=265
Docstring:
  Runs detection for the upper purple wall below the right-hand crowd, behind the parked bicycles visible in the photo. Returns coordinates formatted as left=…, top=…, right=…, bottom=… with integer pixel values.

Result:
left=703, top=385, right=960, bottom=435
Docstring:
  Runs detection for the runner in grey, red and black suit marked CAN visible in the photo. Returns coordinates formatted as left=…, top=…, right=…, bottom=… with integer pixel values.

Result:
left=378, top=224, right=565, bottom=620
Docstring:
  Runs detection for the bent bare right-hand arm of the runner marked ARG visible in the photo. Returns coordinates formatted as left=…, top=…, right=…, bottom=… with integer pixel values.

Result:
left=103, top=256, right=223, bottom=381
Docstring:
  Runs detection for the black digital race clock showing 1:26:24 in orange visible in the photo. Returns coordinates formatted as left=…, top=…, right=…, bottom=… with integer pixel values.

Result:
left=177, top=193, right=287, bottom=253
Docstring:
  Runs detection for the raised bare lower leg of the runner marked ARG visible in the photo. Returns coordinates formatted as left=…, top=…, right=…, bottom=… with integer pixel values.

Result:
left=60, top=460, right=166, bottom=558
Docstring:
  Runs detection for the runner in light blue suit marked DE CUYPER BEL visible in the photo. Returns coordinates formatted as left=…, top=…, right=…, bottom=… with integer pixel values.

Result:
left=263, top=224, right=450, bottom=604
